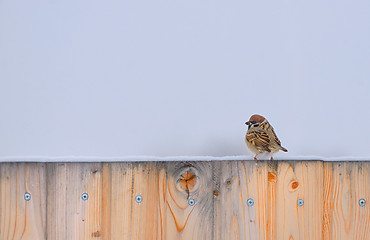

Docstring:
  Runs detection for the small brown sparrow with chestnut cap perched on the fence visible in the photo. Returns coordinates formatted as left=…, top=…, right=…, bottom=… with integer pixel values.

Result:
left=245, top=114, right=288, bottom=161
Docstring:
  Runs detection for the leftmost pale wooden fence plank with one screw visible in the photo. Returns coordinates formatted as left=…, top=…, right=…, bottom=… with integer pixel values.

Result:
left=0, top=163, right=46, bottom=240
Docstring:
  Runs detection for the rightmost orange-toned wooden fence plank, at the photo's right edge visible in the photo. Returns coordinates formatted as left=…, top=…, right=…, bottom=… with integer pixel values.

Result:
left=322, top=162, right=370, bottom=240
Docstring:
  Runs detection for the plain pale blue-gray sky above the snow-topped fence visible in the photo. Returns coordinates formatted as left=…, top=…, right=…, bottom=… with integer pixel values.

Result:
left=0, top=0, right=370, bottom=159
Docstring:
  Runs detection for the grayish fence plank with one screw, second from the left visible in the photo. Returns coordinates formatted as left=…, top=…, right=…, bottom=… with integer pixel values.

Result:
left=47, top=163, right=102, bottom=239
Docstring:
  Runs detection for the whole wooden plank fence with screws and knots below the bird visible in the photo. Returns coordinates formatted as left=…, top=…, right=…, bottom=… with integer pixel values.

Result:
left=0, top=161, right=370, bottom=240
